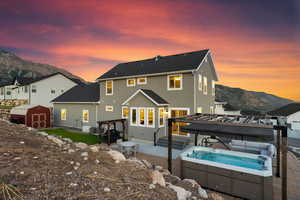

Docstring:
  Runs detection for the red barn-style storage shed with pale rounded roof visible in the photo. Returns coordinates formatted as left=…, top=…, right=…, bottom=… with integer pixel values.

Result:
left=10, top=104, right=51, bottom=128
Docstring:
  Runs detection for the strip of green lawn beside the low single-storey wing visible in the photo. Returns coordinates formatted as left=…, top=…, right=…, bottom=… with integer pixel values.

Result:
left=43, top=128, right=99, bottom=145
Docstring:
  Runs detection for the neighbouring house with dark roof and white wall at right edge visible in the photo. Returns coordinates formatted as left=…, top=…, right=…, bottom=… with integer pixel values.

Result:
left=268, top=103, right=300, bottom=130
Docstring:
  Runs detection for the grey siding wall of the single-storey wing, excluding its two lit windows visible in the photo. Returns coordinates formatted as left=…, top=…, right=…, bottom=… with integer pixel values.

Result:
left=53, top=103, right=99, bottom=129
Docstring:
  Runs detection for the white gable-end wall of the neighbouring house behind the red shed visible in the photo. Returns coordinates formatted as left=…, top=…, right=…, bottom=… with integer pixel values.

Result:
left=30, top=74, right=76, bottom=107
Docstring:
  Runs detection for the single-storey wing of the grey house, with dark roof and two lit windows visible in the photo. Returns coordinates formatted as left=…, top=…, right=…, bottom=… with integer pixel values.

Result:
left=52, top=83, right=100, bottom=130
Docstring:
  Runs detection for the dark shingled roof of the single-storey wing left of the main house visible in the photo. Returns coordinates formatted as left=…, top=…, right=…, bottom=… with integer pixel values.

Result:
left=52, top=83, right=100, bottom=103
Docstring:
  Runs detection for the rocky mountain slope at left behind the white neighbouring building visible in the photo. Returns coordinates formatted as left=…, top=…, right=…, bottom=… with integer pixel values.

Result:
left=0, top=49, right=85, bottom=84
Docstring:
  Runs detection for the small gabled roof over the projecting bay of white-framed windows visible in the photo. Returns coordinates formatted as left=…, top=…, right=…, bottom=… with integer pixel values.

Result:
left=122, top=89, right=169, bottom=106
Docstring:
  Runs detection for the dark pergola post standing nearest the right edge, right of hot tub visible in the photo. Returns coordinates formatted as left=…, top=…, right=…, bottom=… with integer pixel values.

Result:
left=281, top=126, right=288, bottom=200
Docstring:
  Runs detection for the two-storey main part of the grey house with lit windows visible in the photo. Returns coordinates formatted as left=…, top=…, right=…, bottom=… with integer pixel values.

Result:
left=97, top=50, right=218, bottom=141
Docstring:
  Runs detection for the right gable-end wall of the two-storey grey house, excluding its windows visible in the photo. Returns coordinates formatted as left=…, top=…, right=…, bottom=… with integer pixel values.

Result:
left=191, top=53, right=216, bottom=113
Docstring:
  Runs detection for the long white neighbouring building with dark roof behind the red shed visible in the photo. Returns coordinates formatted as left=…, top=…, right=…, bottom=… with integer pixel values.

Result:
left=1, top=73, right=78, bottom=107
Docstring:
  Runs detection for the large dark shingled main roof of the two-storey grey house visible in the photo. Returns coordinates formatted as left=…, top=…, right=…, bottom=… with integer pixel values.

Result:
left=97, top=49, right=209, bottom=80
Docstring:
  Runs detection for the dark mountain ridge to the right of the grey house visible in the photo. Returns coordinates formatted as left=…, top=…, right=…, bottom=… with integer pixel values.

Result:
left=216, top=85, right=293, bottom=114
